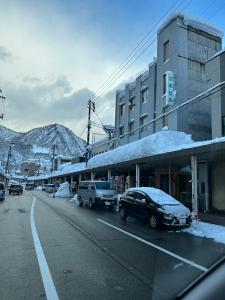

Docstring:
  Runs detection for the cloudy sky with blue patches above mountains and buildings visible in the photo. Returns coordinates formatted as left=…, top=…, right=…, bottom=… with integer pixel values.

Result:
left=0, top=0, right=225, bottom=138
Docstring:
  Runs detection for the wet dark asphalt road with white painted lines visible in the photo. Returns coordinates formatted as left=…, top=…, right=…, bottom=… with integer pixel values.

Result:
left=0, top=191, right=225, bottom=300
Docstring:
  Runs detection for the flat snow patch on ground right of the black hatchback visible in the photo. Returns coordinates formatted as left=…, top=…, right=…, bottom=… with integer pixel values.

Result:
left=182, top=221, right=225, bottom=244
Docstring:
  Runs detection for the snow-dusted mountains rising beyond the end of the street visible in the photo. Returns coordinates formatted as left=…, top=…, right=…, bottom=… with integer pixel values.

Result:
left=0, top=124, right=85, bottom=166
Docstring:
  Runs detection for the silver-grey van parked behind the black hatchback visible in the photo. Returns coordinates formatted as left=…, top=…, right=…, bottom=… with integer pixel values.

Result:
left=77, top=181, right=117, bottom=208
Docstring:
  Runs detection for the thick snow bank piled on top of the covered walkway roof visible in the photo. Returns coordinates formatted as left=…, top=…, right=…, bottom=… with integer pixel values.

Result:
left=88, top=130, right=193, bottom=168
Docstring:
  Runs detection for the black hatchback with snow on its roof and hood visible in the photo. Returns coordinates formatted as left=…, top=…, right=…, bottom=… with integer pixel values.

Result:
left=119, top=187, right=192, bottom=228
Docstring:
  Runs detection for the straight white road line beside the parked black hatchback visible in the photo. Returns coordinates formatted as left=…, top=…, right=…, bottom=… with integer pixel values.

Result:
left=96, top=219, right=208, bottom=272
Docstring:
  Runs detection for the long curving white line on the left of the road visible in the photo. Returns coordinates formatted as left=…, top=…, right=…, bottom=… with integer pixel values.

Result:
left=30, top=197, right=59, bottom=300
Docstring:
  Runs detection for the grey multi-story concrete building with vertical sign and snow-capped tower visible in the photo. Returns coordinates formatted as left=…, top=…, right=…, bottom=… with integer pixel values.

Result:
left=115, top=14, right=223, bottom=146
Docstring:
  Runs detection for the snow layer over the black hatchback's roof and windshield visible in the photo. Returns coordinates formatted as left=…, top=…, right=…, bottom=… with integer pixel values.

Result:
left=128, top=187, right=180, bottom=205
